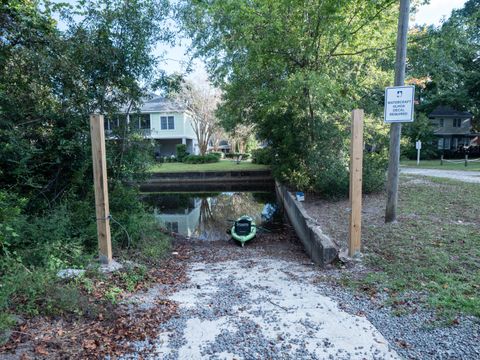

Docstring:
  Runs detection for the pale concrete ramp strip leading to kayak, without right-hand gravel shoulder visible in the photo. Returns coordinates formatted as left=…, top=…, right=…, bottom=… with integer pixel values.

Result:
left=123, top=238, right=399, bottom=359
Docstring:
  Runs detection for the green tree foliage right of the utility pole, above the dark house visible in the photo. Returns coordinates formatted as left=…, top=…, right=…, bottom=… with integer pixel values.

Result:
left=407, top=0, right=480, bottom=120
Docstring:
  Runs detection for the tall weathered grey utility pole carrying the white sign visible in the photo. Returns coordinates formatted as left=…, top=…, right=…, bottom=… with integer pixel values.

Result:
left=385, top=0, right=410, bottom=223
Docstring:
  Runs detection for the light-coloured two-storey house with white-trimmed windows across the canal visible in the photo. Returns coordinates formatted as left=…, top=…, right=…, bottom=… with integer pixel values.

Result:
left=105, top=96, right=198, bottom=156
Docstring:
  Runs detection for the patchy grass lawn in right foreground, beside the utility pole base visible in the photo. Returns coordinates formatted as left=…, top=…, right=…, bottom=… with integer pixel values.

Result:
left=345, top=177, right=480, bottom=320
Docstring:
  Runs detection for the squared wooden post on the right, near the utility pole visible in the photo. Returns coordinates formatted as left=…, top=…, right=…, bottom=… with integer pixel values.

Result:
left=348, top=109, right=363, bottom=256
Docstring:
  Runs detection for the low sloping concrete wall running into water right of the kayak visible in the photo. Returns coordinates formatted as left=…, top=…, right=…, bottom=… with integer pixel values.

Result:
left=275, top=182, right=339, bottom=266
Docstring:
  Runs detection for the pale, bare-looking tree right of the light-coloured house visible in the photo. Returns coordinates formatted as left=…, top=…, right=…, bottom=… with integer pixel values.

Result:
left=176, top=80, right=220, bottom=155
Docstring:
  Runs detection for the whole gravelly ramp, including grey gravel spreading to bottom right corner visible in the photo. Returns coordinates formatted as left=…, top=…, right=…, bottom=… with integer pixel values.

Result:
left=123, top=234, right=480, bottom=360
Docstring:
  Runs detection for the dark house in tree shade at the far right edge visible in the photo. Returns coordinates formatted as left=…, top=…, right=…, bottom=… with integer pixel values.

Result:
left=428, top=106, right=479, bottom=150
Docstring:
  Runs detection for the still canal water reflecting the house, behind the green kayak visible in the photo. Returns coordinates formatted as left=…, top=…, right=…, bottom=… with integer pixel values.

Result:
left=143, top=191, right=281, bottom=241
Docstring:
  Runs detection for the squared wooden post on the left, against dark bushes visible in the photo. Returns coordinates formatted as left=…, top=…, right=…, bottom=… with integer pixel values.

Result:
left=90, top=114, right=112, bottom=264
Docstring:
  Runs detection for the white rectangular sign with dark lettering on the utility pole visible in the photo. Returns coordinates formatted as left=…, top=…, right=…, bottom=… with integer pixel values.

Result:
left=385, top=86, right=415, bottom=123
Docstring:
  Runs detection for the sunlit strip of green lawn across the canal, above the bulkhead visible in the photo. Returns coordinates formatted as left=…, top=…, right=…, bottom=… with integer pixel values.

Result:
left=150, top=160, right=270, bottom=172
